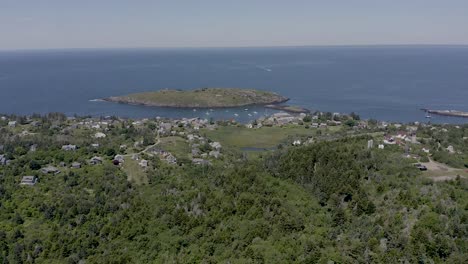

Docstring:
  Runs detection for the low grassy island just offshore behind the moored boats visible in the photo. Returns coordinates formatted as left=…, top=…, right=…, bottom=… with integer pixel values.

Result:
left=103, top=88, right=289, bottom=108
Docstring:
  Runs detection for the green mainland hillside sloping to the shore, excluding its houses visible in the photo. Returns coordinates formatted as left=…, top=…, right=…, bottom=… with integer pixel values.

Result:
left=0, top=114, right=468, bottom=263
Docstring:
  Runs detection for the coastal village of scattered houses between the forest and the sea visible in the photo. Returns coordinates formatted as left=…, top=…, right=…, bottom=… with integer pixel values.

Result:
left=0, top=112, right=467, bottom=186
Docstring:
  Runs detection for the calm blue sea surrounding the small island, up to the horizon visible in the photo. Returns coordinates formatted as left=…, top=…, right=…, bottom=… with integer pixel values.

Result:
left=0, top=46, right=468, bottom=123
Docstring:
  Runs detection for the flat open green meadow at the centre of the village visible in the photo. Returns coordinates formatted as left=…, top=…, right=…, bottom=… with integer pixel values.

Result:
left=202, top=126, right=317, bottom=149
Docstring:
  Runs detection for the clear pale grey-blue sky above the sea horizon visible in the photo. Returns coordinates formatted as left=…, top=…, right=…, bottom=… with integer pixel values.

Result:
left=0, top=0, right=468, bottom=49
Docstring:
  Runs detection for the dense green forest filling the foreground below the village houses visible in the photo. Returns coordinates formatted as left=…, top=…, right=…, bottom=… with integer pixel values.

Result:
left=0, top=114, right=468, bottom=263
